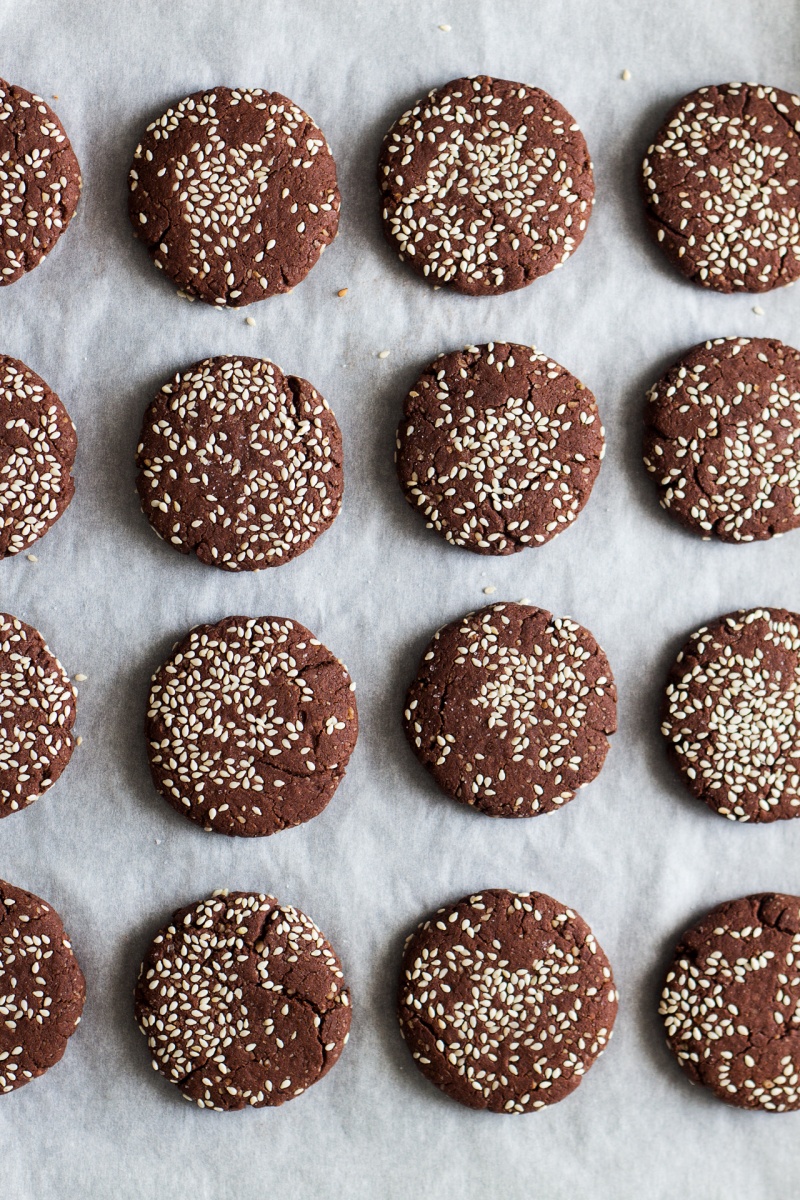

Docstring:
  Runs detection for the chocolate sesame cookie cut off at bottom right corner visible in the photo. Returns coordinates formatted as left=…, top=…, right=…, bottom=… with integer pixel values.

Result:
left=658, top=892, right=800, bottom=1112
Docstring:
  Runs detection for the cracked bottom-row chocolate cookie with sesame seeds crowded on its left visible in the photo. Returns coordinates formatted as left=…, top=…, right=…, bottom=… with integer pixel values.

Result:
left=134, top=892, right=350, bottom=1111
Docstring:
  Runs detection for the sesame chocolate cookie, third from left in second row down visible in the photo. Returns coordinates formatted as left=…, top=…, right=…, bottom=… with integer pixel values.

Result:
left=396, top=342, right=606, bottom=554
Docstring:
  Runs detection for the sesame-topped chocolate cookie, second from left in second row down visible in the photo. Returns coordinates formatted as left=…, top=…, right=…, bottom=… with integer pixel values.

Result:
left=137, top=356, right=344, bottom=571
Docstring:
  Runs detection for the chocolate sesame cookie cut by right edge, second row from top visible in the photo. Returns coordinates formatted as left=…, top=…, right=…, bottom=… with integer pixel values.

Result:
left=644, top=337, right=800, bottom=541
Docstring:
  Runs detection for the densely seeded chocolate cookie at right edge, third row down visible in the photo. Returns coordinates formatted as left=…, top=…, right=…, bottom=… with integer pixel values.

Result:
left=661, top=608, right=800, bottom=822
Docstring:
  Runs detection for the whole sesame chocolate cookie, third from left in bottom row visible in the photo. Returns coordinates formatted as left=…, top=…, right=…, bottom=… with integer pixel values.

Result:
left=398, top=888, right=618, bottom=1112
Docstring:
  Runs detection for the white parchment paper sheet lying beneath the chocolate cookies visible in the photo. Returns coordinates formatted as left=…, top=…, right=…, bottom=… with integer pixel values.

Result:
left=0, top=0, right=800, bottom=1200
